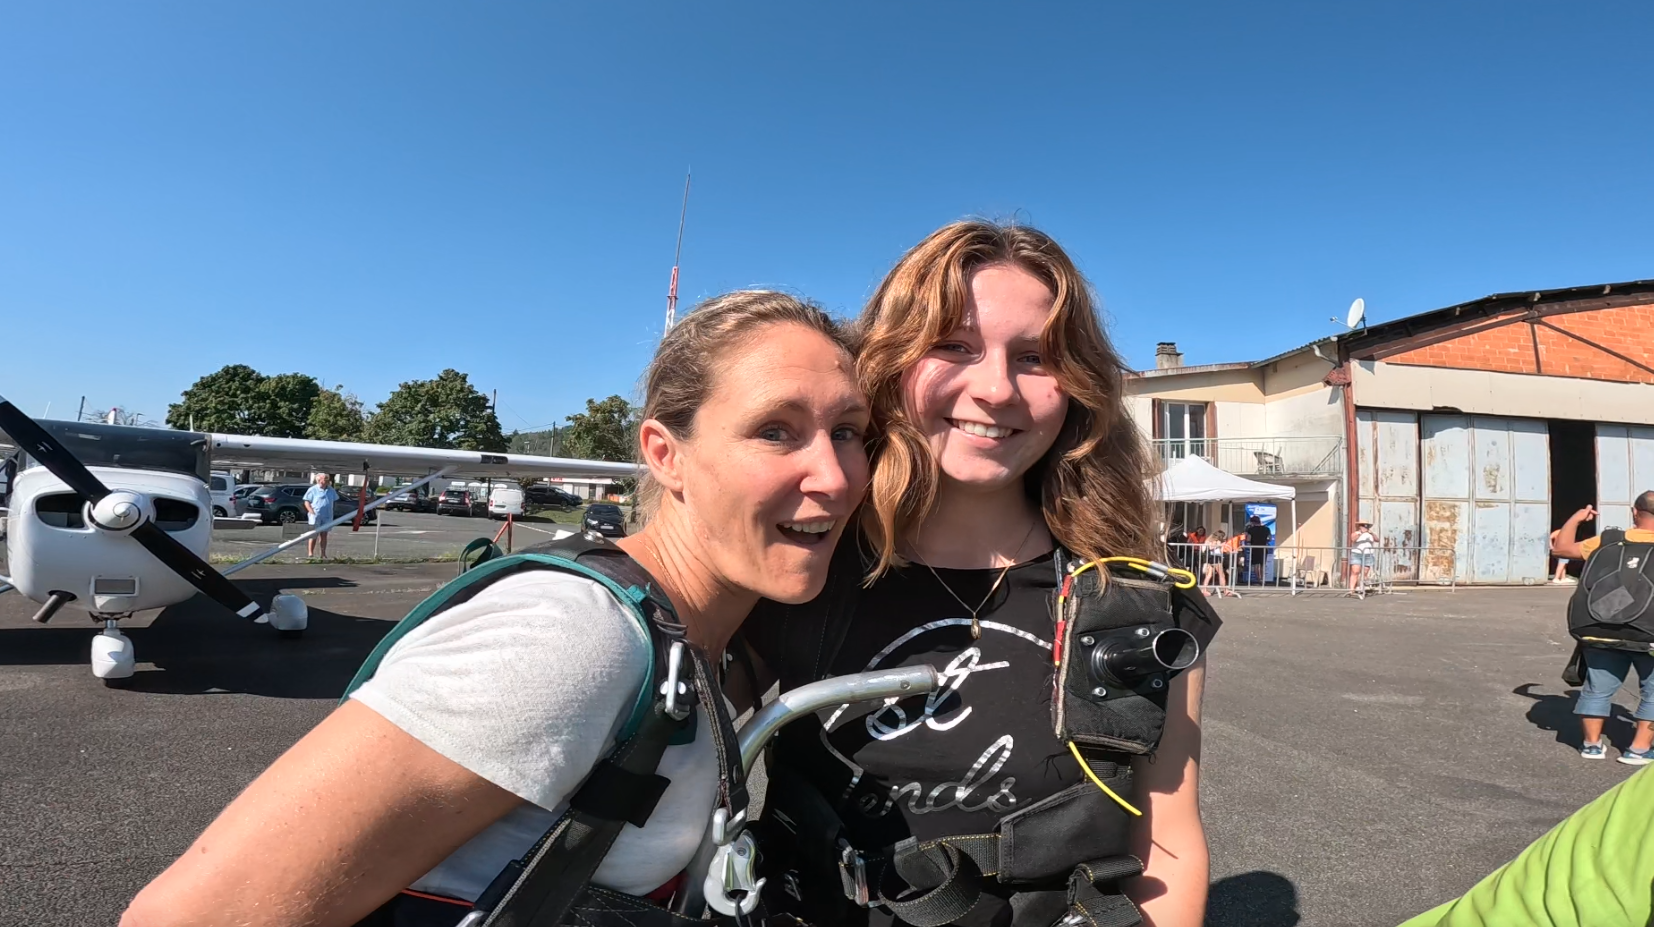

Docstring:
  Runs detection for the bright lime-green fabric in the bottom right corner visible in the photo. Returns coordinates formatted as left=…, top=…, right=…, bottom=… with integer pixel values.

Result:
left=1401, top=770, right=1654, bottom=927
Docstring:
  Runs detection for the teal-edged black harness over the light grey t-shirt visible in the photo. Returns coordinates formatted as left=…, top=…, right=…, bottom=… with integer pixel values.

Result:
left=346, top=535, right=759, bottom=927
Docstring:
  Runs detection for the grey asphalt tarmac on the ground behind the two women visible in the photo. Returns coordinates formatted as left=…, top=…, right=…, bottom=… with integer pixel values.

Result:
left=0, top=564, right=1632, bottom=927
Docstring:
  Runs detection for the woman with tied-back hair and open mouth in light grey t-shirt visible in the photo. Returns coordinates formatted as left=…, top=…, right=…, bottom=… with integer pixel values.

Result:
left=122, top=291, right=868, bottom=927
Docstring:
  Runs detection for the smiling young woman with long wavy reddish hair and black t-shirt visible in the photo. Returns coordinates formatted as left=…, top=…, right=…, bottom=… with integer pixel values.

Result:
left=746, top=222, right=1217, bottom=927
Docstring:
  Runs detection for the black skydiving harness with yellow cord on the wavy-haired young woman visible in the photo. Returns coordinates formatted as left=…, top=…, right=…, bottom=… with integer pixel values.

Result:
left=761, top=543, right=1207, bottom=927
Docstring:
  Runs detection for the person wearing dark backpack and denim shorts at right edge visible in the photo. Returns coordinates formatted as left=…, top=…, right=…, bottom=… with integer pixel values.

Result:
left=1551, top=490, right=1654, bottom=766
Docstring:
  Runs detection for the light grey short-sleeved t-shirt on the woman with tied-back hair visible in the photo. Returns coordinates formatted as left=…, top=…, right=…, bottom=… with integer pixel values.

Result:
left=351, top=569, right=718, bottom=901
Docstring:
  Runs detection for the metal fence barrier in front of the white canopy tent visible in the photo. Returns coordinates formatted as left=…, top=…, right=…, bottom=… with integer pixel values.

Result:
left=1166, top=545, right=1457, bottom=598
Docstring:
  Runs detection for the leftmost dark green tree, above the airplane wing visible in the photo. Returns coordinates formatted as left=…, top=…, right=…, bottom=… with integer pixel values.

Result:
left=167, top=364, right=321, bottom=437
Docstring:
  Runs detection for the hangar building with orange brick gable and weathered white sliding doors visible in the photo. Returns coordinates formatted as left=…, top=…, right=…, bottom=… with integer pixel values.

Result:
left=1128, top=280, right=1654, bottom=584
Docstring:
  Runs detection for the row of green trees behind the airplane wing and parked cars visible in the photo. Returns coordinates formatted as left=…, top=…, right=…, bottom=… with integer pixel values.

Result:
left=167, top=364, right=638, bottom=460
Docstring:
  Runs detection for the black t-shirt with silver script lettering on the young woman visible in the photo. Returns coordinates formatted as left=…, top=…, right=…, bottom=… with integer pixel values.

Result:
left=757, top=555, right=1219, bottom=925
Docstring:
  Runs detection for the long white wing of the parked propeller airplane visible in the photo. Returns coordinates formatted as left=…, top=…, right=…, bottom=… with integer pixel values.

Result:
left=207, top=434, right=638, bottom=480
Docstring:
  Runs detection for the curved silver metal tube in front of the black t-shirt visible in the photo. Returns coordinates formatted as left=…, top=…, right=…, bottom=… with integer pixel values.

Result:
left=673, top=664, right=943, bottom=917
